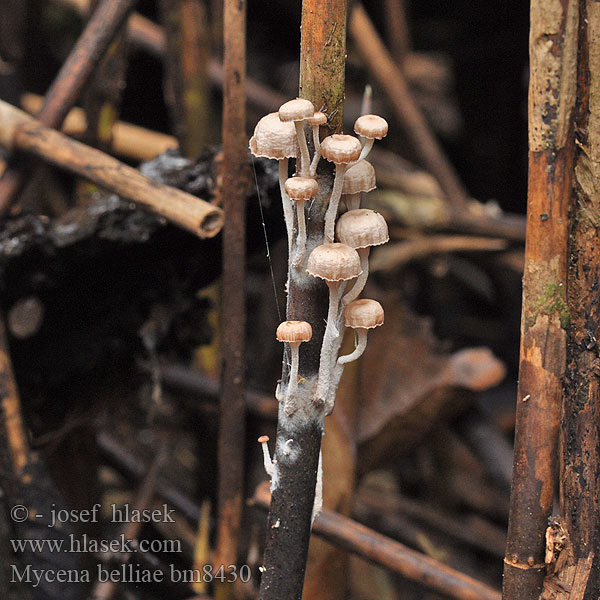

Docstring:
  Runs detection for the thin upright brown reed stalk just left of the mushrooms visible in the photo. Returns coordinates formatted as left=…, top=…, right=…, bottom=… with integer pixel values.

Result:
left=214, top=0, right=248, bottom=598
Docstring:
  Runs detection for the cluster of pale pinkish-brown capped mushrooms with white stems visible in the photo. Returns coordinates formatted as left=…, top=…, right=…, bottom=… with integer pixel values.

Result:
left=250, top=98, right=389, bottom=414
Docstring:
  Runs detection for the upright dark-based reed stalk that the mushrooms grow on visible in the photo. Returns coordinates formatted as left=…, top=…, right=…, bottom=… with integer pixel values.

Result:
left=260, top=0, right=347, bottom=600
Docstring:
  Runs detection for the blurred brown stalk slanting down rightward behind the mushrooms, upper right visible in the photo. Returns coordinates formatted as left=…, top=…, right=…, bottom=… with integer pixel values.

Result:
left=348, top=2, right=469, bottom=210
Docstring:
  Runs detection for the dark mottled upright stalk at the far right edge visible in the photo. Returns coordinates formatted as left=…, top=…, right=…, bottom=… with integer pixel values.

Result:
left=557, top=0, right=600, bottom=600
